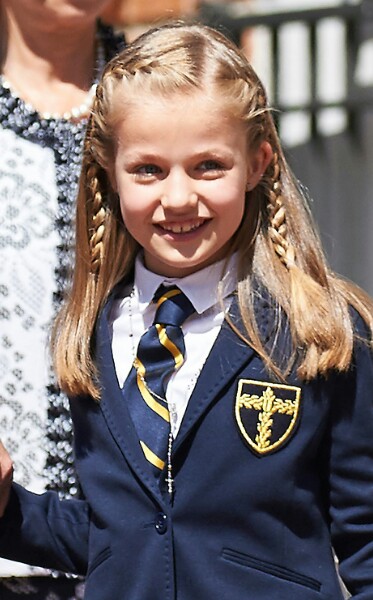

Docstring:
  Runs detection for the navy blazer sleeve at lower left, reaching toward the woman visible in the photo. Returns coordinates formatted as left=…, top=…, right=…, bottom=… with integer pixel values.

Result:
left=0, top=484, right=89, bottom=575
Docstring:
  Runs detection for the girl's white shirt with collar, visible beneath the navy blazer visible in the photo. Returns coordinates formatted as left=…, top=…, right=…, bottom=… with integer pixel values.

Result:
left=110, top=254, right=236, bottom=437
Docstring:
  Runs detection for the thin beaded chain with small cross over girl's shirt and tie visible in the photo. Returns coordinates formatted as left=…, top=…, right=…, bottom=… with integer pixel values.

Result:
left=128, top=287, right=202, bottom=502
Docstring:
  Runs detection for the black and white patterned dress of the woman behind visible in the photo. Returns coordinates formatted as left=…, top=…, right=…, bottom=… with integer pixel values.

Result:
left=0, top=24, right=124, bottom=600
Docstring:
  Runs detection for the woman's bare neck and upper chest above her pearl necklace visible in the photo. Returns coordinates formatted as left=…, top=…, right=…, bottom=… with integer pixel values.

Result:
left=2, top=7, right=96, bottom=114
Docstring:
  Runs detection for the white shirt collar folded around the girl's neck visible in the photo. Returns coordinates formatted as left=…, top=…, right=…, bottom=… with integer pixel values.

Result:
left=134, top=252, right=237, bottom=314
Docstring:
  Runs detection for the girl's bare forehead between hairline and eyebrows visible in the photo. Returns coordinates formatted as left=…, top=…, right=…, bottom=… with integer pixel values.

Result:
left=109, top=92, right=247, bottom=160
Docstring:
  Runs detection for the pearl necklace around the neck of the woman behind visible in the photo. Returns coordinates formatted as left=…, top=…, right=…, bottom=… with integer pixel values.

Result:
left=0, top=42, right=106, bottom=121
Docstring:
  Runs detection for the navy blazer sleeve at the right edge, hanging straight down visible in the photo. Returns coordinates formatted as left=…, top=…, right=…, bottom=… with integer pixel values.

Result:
left=329, top=316, right=373, bottom=600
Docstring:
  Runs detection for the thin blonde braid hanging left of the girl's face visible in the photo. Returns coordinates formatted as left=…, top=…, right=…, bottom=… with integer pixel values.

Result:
left=87, top=163, right=106, bottom=275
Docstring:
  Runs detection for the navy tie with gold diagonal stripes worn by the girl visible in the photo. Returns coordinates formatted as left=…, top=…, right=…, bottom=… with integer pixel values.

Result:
left=122, top=285, right=195, bottom=475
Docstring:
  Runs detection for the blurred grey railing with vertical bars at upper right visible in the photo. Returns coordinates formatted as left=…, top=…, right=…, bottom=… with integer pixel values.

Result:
left=200, top=0, right=373, bottom=137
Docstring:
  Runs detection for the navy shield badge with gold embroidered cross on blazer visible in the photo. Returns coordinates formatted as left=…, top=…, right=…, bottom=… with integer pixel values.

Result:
left=235, top=379, right=301, bottom=455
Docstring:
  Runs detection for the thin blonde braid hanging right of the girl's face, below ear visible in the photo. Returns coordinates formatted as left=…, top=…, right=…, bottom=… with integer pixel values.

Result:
left=268, top=152, right=295, bottom=269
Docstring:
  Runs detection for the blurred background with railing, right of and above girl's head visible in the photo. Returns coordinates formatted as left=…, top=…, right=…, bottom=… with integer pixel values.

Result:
left=100, top=0, right=373, bottom=295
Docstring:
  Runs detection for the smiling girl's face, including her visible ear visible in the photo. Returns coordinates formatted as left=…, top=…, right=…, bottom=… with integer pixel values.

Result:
left=112, top=92, right=272, bottom=277
